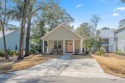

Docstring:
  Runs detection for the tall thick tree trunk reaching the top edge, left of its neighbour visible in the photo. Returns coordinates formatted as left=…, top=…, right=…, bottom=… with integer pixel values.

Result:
left=17, top=0, right=27, bottom=60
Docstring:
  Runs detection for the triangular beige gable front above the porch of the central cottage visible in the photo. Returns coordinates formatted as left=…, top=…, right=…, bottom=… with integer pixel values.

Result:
left=41, top=25, right=82, bottom=40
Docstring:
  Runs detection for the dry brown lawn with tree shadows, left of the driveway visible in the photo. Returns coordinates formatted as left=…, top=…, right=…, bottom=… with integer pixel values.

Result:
left=0, top=55, right=60, bottom=73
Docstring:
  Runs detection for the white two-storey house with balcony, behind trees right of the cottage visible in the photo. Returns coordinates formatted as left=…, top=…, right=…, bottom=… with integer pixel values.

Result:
left=99, top=29, right=114, bottom=52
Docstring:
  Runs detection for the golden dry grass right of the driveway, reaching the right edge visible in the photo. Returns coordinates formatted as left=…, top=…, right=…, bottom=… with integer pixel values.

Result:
left=93, top=53, right=125, bottom=78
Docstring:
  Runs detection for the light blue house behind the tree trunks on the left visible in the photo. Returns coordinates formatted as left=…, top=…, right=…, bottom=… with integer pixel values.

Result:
left=0, top=29, right=25, bottom=50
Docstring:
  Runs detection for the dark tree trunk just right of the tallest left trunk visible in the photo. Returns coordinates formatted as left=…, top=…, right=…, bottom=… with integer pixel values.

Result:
left=25, top=17, right=31, bottom=56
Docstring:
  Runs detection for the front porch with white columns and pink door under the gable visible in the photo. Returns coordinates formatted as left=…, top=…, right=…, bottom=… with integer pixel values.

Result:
left=42, top=40, right=82, bottom=54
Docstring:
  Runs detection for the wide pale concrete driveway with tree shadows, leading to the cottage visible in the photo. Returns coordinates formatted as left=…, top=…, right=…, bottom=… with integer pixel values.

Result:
left=0, top=54, right=125, bottom=83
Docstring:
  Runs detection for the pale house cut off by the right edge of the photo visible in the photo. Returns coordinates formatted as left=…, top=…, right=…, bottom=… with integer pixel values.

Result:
left=114, top=27, right=125, bottom=52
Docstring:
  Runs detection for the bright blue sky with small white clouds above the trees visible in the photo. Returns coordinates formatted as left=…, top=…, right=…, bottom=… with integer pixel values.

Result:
left=60, top=0, right=125, bottom=29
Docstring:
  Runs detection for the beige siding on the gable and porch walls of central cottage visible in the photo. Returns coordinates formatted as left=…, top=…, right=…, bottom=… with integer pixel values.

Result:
left=41, top=25, right=82, bottom=53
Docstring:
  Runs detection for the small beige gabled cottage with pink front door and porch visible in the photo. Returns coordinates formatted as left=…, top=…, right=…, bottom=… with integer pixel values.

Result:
left=41, top=25, right=83, bottom=54
